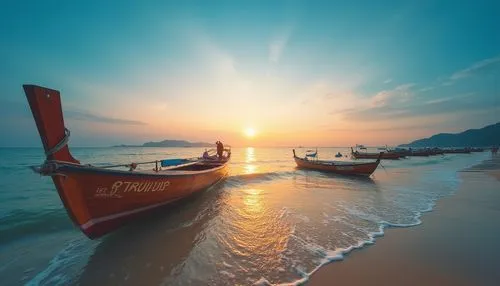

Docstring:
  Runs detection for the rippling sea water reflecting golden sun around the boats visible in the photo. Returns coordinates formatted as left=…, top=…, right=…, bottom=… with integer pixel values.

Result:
left=0, top=148, right=489, bottom=285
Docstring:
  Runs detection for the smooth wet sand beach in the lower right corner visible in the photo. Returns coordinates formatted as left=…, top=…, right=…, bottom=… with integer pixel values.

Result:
left=308, top=156, right=500, bottom=286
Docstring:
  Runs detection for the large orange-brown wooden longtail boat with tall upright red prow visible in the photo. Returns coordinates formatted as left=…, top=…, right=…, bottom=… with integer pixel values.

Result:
left=23, top=85, right=231, bottom=239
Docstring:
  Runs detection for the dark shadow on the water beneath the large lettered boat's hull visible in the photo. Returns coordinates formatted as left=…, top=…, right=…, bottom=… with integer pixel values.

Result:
left=74, top=182, right=225, bottom=285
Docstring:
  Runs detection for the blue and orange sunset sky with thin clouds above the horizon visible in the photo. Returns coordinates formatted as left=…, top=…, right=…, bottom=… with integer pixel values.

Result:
left=0, top=0, right=500, bottom=147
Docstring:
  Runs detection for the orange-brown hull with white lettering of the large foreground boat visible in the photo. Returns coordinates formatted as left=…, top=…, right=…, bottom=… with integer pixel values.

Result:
left=53, top=164, right=227, bottom=238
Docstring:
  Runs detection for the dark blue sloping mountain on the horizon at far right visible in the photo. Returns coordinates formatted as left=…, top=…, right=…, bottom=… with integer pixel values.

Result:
left=399, top=122, right=500, bottom=147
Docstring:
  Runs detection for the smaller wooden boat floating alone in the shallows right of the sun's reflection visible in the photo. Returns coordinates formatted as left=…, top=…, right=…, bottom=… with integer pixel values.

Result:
left=293, top=149, right=382, bottom=176
